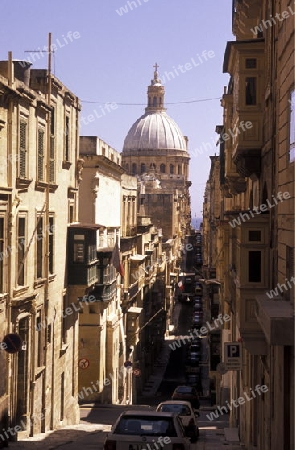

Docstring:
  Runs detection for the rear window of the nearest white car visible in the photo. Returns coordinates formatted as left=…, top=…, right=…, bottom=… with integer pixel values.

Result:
left=114, top=416, right=177, bottom=437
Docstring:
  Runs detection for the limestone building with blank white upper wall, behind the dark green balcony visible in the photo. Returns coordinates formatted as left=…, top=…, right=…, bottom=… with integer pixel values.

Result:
left=76, top=136, right=125, bottom=403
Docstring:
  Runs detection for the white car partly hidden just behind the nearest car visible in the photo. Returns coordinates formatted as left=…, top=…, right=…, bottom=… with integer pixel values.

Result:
left=156, top=400, right=199, bottom=442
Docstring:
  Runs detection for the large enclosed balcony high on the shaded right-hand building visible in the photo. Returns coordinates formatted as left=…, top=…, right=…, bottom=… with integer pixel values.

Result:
left=223, top=39, right=265, bottom=178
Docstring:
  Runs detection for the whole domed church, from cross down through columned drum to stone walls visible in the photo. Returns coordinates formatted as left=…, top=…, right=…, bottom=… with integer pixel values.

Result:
left=122, top=65, right=191, bottom=242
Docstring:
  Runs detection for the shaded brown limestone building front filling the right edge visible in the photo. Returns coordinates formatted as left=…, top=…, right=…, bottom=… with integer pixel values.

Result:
left=204, top=0, right=295, bottom=450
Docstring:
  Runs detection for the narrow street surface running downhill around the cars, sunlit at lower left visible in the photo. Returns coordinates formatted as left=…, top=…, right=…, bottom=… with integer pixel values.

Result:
left=10, top=303, right=240, bottom=450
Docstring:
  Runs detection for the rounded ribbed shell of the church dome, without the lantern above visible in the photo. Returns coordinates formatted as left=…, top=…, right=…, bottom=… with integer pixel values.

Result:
left=123, top=111, right=186, bottom=151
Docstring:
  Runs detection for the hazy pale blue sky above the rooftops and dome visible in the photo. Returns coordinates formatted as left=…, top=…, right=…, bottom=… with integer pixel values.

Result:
left=0, top=0, right=233, bottom=217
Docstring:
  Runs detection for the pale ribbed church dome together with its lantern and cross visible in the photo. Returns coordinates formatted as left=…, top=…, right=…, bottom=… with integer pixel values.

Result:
left=123, top=64, right=187, bottom=152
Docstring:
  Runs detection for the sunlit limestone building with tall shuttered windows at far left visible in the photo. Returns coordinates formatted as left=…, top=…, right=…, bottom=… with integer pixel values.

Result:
left=0, top=56, right=80, bottom=442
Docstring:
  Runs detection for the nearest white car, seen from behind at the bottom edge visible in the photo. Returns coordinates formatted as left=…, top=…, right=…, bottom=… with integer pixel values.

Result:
left=103, top=410, right=191, bottom=450
